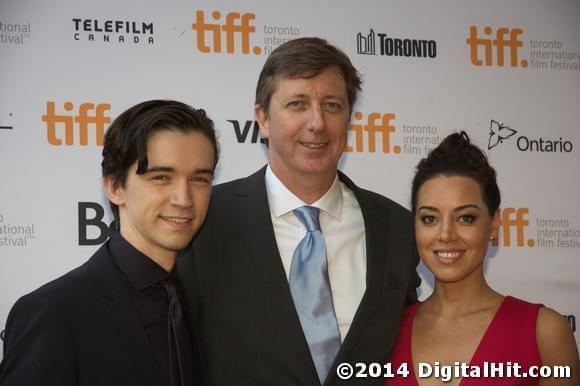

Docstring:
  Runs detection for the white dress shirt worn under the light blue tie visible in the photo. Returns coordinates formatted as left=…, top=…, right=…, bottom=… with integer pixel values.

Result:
left=266, top=166, right=367, bottom=341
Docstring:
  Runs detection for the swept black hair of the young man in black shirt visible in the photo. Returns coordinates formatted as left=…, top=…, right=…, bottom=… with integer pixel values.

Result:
left=101, top=100, right=218, bottom=225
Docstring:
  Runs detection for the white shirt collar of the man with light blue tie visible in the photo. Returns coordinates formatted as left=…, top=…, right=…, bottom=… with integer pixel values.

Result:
left=265, top=165, right=342, bottom=219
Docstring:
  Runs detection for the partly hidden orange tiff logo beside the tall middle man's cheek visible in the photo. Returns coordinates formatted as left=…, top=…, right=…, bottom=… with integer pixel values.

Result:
left=344, top=111, right=401, bottom=153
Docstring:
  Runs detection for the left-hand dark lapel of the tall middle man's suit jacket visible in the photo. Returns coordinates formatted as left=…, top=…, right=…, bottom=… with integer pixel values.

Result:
left=236, top=167, right=316, bottom=376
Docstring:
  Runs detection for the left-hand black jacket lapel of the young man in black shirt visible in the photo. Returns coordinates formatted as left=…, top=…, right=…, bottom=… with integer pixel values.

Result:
left=89, top=244, right=162, bottom=386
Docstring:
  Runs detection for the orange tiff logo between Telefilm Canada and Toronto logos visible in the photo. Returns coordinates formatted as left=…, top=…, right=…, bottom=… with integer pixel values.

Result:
left=191, top=11, right=262, bottom=55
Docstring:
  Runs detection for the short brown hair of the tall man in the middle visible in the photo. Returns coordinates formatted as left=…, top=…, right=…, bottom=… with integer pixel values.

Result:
left=256, top=37, right=362, bottom=114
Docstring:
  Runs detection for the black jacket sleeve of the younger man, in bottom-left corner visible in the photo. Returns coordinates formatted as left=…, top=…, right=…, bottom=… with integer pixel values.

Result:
left=0, top=294, right=76, bottom=386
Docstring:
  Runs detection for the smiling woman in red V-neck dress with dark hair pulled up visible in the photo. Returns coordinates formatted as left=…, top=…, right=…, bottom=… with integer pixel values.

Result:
left=386, top=132, right=580, bottom=386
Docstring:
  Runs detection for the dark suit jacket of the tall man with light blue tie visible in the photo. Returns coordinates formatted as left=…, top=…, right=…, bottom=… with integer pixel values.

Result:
left=178, top=168, right=419, bottom=386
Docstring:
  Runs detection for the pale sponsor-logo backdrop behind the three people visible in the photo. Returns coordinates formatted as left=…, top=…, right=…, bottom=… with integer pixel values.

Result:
left=0, top=0, right=580, bottom=354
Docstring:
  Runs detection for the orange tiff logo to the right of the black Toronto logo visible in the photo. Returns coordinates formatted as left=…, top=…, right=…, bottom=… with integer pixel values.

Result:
left=465, top=26, right=528, bottom=68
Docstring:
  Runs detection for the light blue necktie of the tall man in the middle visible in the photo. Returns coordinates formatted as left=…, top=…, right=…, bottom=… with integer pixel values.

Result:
left=290, top=206, right=340, bottom=383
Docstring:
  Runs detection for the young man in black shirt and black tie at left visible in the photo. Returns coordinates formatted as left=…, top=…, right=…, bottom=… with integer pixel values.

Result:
left=0, top=100, right=217, bottom=386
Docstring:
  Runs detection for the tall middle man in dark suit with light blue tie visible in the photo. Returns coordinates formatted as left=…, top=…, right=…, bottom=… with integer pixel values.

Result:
left=178, top=38, right=419, bottom=386
